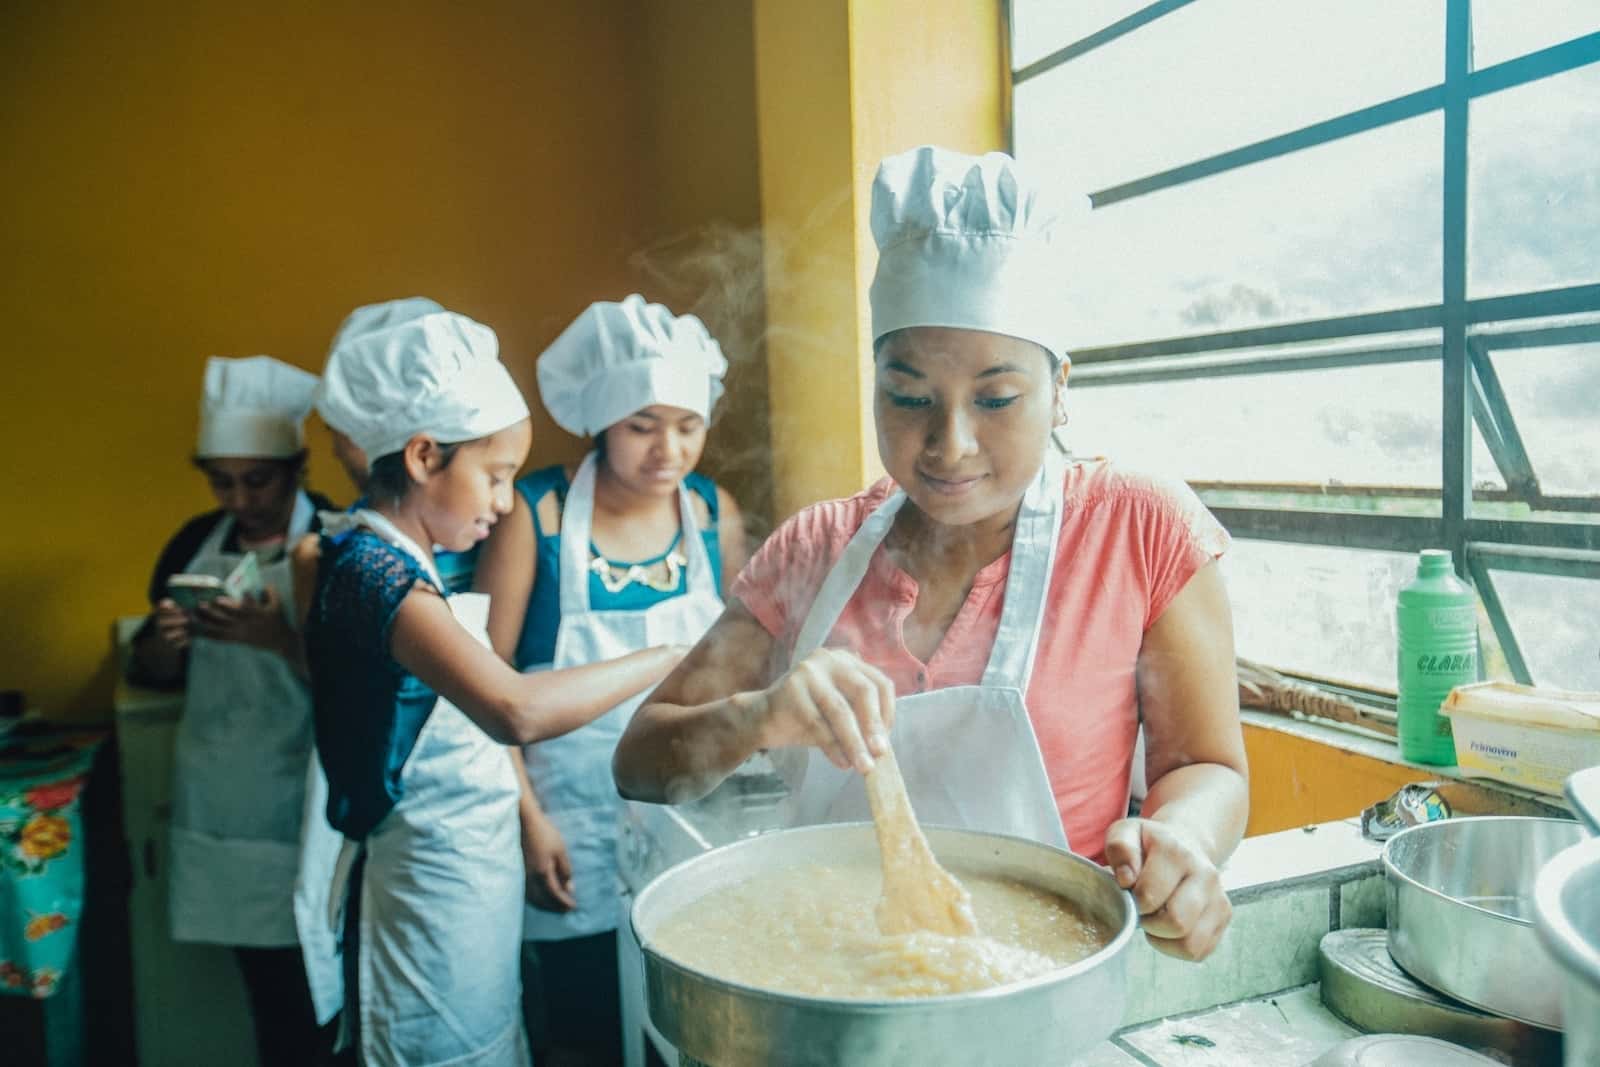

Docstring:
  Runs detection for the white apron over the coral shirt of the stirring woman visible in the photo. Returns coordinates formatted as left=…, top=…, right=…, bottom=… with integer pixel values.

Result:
left=789, top=456, right=1067, bottom=848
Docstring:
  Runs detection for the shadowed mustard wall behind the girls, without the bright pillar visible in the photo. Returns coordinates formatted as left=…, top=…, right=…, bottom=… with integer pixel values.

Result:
left=0, top=0, right=760, bottom=717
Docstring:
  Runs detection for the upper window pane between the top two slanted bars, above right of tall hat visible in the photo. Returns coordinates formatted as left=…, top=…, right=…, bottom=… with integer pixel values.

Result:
left=1014, top=0, right=1445, bottom=191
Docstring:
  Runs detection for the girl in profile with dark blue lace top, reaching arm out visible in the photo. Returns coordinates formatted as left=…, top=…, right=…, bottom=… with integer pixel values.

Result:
left=298, top=312, right=682, bottom=1067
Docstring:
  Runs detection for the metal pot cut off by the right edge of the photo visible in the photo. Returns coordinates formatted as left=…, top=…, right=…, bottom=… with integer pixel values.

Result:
left=1533, top=766, right=1600, bottom=1067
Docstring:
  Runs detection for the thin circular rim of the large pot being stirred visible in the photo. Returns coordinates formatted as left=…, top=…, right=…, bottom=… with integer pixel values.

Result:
left=627, top=822, right=1139, bottom=1014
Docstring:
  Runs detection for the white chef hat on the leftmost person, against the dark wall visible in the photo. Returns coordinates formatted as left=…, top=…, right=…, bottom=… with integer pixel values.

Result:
left=195, top=355, right=317, bottom=459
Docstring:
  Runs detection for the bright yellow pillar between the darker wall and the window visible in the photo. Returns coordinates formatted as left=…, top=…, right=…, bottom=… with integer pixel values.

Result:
left=755, top=0, right=1006, bottom=517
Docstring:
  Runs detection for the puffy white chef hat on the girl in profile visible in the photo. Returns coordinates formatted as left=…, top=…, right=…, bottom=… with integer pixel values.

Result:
left=317, top=310, right=528, bottom=464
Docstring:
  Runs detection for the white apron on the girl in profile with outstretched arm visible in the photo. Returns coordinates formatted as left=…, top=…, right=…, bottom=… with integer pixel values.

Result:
left=330, top=510, right=531, bottom=1067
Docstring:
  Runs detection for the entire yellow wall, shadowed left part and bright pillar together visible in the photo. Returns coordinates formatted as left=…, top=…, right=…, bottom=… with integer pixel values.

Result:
left=0, top=0, right=1003, bottom=717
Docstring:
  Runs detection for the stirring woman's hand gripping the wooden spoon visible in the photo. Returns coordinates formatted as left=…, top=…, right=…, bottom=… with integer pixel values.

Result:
left=760, top=648, right=894, bottom=774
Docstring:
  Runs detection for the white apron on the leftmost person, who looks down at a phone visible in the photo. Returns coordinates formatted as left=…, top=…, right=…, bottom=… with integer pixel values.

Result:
left=168, top=493, right=328, bottom=947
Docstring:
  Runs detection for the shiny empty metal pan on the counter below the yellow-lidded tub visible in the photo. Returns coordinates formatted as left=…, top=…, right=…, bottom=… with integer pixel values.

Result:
left=1384, top=816, right=1584, bottom=1030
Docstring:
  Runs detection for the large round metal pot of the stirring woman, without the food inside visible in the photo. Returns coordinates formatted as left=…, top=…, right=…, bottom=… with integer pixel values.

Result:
left=632, top=822, right=1138, bottom=1067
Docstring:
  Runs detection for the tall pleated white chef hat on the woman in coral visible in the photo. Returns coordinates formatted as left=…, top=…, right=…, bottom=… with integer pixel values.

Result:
left=870, top=146, right=1072, bottom=362
